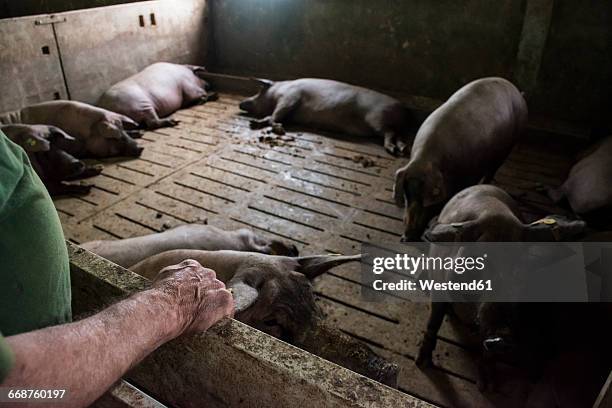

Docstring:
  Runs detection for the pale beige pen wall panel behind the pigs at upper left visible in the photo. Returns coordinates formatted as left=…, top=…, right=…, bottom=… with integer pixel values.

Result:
left=0, top=0, right=208, bottom=112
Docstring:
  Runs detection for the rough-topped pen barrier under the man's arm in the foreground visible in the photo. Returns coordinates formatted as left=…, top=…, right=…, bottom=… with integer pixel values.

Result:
left=68, top=243, right=432, bottom=408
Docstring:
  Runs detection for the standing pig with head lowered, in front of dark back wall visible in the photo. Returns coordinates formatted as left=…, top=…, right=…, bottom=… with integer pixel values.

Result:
left=393, top=77, right=527, bottom=241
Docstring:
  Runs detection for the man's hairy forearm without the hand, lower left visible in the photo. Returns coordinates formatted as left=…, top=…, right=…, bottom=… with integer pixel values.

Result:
left=2, top=290, right=182, bottom=406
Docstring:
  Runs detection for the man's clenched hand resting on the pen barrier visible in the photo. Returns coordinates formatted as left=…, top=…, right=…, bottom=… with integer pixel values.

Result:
left=152, top=259, right=234, bottom=335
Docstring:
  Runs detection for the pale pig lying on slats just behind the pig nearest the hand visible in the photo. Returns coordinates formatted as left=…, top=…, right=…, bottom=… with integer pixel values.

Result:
left=81, top=224, right=298, bottom=268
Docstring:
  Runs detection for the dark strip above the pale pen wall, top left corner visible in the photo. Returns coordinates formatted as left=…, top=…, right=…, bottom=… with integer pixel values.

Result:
left=0, top=0, right=151, bottom=18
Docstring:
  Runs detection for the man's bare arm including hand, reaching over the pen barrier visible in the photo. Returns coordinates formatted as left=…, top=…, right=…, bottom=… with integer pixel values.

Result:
left=2, top=261, right=233, bottom=407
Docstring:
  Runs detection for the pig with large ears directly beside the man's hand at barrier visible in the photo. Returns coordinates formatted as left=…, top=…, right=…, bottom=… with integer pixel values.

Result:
left=129, top=249, right=360, bottom=339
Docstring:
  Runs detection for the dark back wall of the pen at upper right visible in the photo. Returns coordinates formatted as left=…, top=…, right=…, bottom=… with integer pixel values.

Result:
left=209, top=0, right=612, bottom=124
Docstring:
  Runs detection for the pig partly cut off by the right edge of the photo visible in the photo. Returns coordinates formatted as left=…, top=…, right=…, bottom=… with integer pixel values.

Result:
left=549, top=136, right=612, bottom=223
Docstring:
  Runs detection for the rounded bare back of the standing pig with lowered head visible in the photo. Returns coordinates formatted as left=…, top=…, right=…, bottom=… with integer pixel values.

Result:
left=412, top=78, right=527, bottom=183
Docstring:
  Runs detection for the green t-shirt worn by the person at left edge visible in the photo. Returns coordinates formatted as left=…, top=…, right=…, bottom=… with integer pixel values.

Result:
left=0, top=131, right=72, bottom=377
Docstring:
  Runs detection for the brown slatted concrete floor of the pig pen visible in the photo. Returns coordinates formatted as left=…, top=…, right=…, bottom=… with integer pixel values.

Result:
left=55, top=94, right=570, bottom=407
